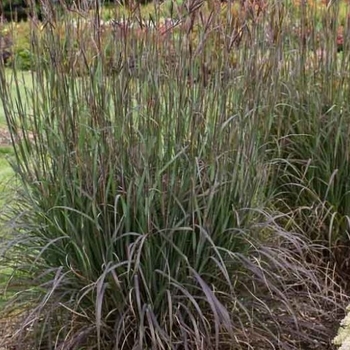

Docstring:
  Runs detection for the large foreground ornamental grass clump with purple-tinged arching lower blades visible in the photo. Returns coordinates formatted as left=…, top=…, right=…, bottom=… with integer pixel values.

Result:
left=0, top=2, right=346, bottom=350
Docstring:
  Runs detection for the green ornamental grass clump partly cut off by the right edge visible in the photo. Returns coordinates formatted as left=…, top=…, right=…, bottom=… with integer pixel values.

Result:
left=275, top=1, right=350, bottom=288
